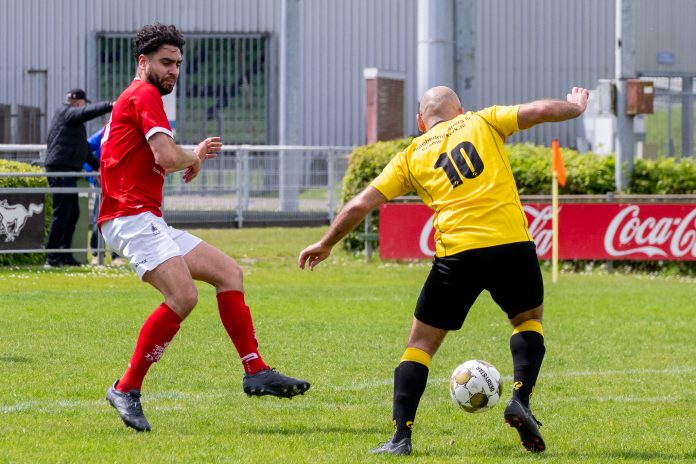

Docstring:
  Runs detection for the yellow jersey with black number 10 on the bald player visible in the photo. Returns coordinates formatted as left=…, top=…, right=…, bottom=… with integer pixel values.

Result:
left=370, top=105, right=533, bottom=257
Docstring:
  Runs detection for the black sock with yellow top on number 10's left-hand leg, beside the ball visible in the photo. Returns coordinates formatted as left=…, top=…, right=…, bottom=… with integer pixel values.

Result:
left=392, top=347, right=431, bottom=442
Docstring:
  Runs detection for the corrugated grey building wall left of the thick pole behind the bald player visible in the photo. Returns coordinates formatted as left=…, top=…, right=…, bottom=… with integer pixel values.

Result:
left=0, top=0, right=416, bottom=145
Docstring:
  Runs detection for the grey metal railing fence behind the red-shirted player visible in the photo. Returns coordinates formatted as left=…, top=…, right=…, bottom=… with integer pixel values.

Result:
left=0, top=145, right=353, bottom=253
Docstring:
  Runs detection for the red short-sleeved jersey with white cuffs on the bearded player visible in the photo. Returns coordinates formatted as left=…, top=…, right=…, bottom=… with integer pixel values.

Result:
left=97, top=79, right=172, bottom=226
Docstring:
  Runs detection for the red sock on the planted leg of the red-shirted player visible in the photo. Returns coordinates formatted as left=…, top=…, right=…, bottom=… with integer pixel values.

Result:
left=116, top=303, right=182, bottom=393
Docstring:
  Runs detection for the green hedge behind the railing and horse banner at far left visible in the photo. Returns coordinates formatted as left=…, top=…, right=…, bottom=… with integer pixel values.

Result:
left=0, top=160, right=53, bottom=266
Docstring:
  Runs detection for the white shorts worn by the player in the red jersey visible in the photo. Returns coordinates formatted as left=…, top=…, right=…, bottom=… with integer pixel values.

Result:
left=101, top=212, right=203, bottom=279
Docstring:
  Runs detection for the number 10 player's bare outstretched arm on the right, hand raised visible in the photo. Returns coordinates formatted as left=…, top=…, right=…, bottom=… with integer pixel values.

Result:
left=517, top=87, right=590, bottom=130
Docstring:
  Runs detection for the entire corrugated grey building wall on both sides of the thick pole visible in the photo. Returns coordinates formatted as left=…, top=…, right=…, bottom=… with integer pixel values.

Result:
left=0, top=0, right=615, bottom=145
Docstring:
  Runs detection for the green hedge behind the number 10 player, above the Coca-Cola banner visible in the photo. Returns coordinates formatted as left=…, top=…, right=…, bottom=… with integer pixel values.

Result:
left=343, top=138, right=696, bottom=251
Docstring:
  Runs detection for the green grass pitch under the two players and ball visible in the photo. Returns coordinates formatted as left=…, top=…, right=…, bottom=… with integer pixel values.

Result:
left=0, top=229, right=696, bottom=463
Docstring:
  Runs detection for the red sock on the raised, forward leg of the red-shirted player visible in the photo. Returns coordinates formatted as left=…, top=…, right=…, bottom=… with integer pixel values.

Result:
left=217, top=290, right=268, bottom=374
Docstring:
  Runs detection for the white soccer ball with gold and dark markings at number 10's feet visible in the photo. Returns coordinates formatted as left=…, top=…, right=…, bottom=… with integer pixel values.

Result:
left=450, top=360, right=503, bottom=413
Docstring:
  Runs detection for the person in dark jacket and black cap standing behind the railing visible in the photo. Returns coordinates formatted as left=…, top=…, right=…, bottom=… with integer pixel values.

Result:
left=44, top=89, right=112, bottom=267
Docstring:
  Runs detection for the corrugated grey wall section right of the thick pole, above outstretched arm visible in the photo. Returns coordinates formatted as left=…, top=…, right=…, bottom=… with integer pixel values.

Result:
left=474, top=0, right=615, bottom=146
